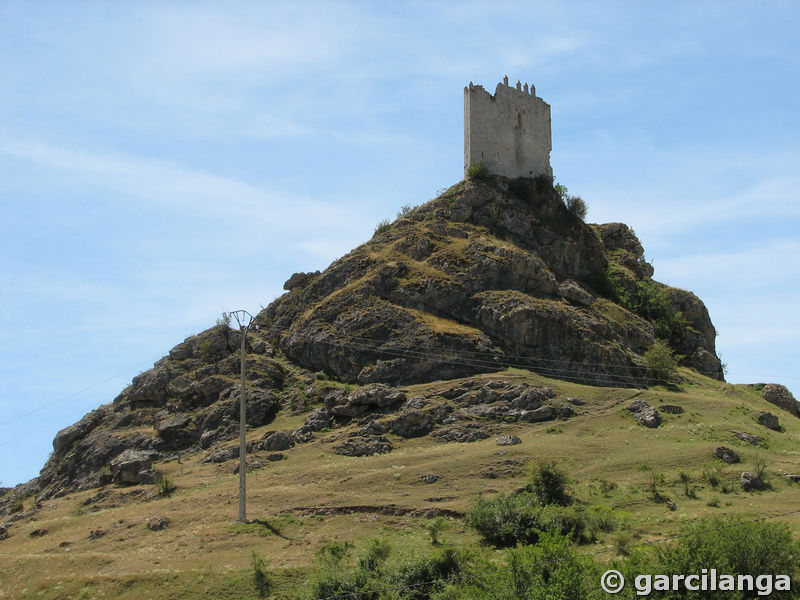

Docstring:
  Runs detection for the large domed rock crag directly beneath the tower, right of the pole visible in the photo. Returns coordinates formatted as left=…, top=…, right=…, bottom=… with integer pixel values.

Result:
left=259, top=178, right=721, bottom=390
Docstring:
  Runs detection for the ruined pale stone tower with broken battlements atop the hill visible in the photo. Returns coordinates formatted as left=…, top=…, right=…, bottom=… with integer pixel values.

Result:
left=464, top=77, right=553, bottom=177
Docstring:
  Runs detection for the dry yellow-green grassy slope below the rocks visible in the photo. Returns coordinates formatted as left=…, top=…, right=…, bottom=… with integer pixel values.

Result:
left=0, top=369, right=800, bottom=599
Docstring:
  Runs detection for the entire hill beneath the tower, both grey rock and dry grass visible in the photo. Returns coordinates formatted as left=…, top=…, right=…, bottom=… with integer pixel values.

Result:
left=0, top=178, right=800, bottom=597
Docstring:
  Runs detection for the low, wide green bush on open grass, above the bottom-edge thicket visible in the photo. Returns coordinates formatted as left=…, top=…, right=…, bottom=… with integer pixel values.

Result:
left=465, top=492, right=590, bottom=548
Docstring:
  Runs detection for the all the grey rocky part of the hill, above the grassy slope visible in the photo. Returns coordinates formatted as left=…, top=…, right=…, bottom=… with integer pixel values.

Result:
left=0, top=177, right=736, bottom=502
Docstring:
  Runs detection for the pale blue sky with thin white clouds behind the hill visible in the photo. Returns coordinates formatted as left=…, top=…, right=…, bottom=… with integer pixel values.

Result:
left=0, top=0, right=800, bottom=485
